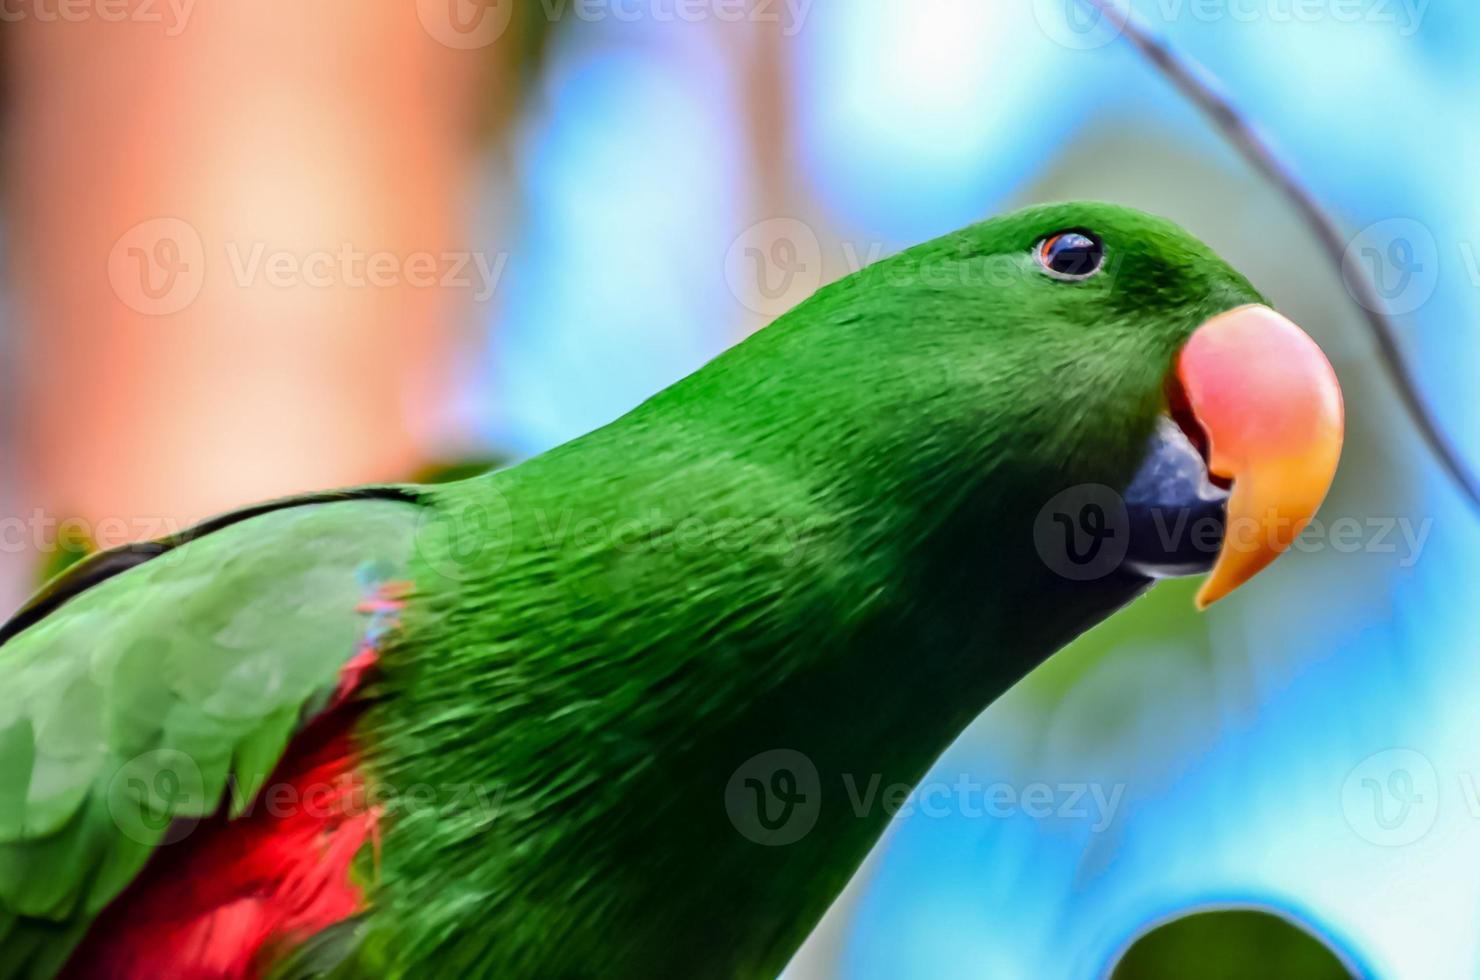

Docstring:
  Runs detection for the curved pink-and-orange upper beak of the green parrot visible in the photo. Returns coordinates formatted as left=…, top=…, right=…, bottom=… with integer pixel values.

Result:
left=1177, top=306, right=1344, bottom=608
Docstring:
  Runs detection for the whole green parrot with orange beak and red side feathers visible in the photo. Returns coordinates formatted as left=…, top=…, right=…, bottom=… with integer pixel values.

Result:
left=0, top=203, right=1342, bottom=980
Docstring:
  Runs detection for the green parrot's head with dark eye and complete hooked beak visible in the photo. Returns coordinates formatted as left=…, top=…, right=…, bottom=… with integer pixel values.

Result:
left=700, top=203, right=1342, bottom=607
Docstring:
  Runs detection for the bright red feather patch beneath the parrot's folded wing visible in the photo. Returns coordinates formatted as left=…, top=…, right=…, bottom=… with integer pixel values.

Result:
left=62, top=644, right=380, bottom=980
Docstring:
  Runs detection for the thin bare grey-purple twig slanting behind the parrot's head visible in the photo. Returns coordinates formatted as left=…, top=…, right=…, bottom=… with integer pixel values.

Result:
left=1080, top=0, right=1480, bottom=509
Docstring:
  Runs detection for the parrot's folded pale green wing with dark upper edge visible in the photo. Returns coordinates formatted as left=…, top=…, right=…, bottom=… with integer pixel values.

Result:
left=0, top=487, right=426, bottom=979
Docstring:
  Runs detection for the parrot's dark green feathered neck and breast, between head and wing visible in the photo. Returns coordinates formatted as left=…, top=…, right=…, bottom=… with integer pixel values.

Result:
left=366, top=393, right=1147, bottom=976
